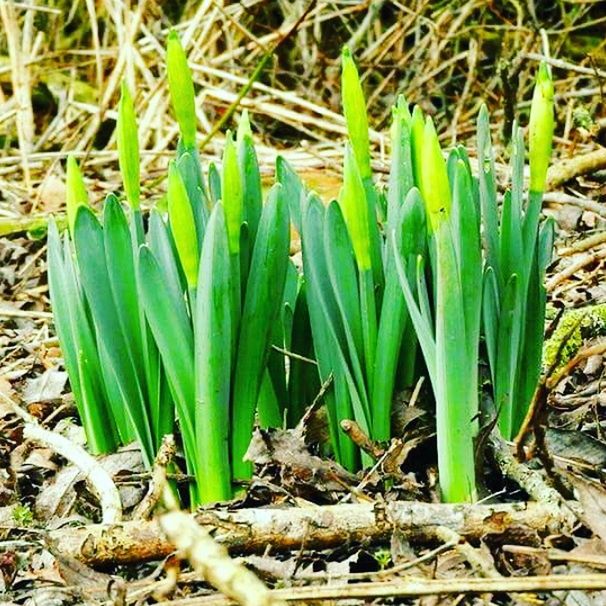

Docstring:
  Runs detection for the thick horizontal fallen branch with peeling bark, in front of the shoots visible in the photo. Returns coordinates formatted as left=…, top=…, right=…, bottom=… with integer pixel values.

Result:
left=50, top=502, right=565, bottom=566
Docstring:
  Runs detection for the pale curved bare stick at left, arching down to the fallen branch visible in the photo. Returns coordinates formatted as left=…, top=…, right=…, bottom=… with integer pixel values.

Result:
left=0, top=391, right=122, bottom=524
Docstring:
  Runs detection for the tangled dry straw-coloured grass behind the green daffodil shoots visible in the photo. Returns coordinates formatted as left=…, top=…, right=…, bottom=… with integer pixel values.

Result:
left=0, top=0, right=606, bottom=228
